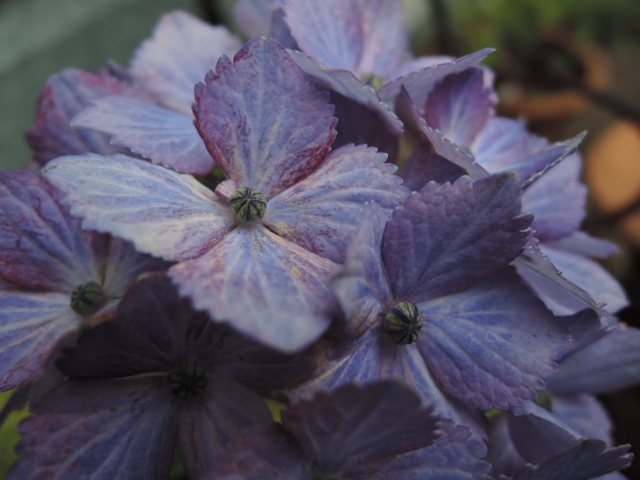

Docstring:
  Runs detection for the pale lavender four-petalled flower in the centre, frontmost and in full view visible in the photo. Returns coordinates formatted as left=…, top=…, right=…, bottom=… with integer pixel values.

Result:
left=45, top=39, right=408, bottom=350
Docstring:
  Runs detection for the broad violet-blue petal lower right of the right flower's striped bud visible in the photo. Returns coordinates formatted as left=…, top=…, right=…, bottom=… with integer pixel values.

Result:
left=417, top=269, right=575, bottom=411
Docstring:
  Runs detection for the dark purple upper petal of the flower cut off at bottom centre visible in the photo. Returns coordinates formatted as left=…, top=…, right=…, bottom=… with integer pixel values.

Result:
left=282, top=381, right=438, bottom=478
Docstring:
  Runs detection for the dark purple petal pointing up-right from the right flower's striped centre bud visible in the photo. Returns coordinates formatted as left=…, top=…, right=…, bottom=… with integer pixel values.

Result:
left=382, top=173, right=531, bottom=303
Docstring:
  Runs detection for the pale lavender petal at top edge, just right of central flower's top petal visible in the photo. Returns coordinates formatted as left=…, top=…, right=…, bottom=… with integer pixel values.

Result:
left=283, top=0, right=366, bottom=74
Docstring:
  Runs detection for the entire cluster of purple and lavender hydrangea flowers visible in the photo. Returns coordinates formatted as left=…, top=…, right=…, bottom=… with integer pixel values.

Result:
left=0, top=0, right=640, bottom=480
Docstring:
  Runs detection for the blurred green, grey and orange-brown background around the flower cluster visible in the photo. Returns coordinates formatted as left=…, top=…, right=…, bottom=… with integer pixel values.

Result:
left=0, top=0, right=640, bottom=479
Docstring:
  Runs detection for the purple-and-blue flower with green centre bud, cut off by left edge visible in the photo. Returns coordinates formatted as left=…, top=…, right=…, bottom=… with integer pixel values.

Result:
left=0, top=170, right=167, bottom=391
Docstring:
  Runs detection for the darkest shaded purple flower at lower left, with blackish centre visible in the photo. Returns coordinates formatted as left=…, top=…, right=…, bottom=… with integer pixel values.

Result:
left=9, top=275, right=309, bottom=480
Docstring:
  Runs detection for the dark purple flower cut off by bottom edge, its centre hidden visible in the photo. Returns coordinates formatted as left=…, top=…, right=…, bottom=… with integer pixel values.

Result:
left=205, top=381, right=489, bottom=480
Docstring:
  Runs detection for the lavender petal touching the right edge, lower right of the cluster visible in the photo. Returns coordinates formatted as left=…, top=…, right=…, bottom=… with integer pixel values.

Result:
left=548, top=324, right=640, bottom=395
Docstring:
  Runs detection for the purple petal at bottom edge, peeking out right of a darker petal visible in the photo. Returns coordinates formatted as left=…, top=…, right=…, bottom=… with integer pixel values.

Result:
left=352, top=420, right=491, bottom=480
